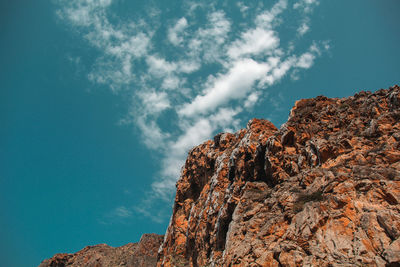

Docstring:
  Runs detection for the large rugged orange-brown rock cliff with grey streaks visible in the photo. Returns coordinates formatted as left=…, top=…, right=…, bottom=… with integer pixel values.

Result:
left=157, top=86, right=400, bottom=266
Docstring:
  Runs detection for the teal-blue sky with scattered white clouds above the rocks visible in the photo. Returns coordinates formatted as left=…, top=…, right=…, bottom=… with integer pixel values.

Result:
left=0, top=0, right=400, bottom=266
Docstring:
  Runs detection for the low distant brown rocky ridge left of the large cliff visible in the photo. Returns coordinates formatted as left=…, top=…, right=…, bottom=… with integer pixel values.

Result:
left=39, top=234, right=163, bottom=267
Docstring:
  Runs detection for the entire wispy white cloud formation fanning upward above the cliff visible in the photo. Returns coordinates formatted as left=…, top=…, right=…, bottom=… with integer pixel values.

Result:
left=58, top=0, right=327, bottom=222
